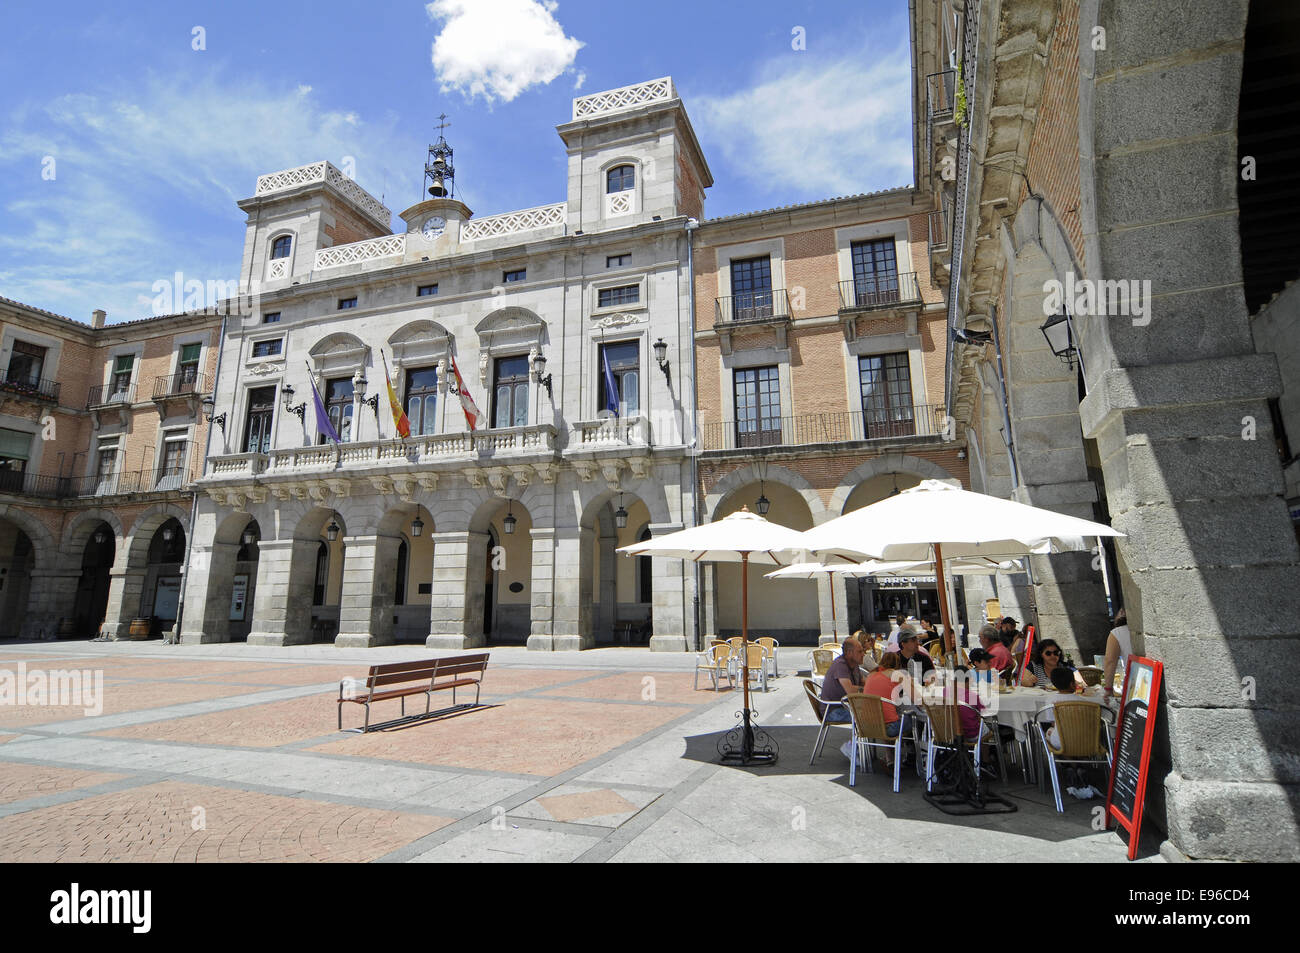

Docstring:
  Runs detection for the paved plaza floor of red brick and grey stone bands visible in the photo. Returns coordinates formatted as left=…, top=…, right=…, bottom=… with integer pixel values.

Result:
left=0, top=642, right=1160, bottom=862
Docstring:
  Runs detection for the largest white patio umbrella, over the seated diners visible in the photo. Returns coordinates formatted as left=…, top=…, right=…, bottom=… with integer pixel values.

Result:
left=803, top=480, right=1123, bottom=647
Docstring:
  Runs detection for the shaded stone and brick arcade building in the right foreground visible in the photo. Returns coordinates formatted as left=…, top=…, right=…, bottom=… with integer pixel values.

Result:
left=913, top=0, right=1300, bottom=859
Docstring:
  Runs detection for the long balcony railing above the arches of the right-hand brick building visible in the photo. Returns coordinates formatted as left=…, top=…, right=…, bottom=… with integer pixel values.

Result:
left=699, top=404, right=944, bottom=451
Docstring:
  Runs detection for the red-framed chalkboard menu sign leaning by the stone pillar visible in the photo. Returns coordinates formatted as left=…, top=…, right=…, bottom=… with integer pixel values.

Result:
left=1106, top=655, right=1165, bottom=861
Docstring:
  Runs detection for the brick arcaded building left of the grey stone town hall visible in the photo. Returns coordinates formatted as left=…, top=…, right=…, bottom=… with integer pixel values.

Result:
left=0, top=299, right=221, bottom=638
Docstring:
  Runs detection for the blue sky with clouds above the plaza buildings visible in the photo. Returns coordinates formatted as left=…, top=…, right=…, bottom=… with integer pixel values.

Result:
left=0, top=0, right=911, bottom=322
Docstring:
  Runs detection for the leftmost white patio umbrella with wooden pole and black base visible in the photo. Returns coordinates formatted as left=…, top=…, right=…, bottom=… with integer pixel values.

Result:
left=618, top=507, right=803, bottom=764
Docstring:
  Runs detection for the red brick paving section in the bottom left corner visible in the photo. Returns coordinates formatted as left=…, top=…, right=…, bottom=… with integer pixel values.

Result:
left=0, top=781, right=450, bottom=863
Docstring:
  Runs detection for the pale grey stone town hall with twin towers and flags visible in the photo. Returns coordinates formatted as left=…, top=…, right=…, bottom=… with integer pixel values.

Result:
left=182, top=78, right=712, bottom=650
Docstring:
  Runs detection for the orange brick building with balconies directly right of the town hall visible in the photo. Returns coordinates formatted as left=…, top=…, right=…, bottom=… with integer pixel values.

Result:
left=693, top=187, right=983, bottom=644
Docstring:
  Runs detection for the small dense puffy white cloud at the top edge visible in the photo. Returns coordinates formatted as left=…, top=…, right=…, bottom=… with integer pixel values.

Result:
left=426, top=0, right=584, bottom=103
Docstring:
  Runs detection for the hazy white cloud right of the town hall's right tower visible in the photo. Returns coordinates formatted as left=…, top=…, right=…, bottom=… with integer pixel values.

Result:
left=686, top=49, right=913, bottom=203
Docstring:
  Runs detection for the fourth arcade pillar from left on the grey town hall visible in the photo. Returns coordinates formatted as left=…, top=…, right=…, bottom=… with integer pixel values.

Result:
left=424, top=532, right=490, bottom=649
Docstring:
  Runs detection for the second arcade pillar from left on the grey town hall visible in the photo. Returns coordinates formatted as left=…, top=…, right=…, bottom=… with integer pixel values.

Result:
left=248, top=540, right=320, bottom=645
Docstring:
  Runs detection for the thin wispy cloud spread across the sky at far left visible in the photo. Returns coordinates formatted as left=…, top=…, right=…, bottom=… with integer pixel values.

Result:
left=0, top=74, right=424, bottom=321
